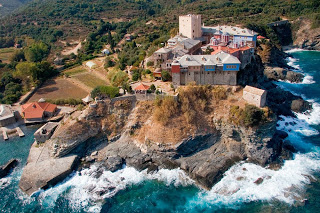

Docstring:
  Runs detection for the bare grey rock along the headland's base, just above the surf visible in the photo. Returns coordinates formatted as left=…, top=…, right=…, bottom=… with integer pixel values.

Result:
left=103, top=117, right=290, bottom=188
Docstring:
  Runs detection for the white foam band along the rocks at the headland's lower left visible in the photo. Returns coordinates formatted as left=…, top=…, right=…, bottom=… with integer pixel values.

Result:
left=39, top=165, right=194, bottom=212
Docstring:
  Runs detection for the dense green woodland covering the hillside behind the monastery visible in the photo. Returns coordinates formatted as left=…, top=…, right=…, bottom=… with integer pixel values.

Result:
left=0, top=0, right=320, bottom=103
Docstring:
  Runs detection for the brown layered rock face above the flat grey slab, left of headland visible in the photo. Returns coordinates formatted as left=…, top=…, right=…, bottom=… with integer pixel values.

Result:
left=49, top=100, right=133, bottom=157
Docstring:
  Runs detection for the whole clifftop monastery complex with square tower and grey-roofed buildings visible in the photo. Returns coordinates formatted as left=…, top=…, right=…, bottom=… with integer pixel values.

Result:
left=152, top=14, right=257, bottom=86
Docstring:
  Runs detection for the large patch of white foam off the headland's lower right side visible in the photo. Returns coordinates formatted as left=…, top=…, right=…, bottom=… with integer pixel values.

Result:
left=188, top=153, right=320, bottom=208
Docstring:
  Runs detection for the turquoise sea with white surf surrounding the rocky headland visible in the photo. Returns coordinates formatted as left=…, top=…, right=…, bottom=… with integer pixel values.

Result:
left=0, top=49, right=320, bottom=213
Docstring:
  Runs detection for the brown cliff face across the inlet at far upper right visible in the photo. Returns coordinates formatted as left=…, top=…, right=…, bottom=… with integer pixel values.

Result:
left=293, top=18, right=320, bottom=50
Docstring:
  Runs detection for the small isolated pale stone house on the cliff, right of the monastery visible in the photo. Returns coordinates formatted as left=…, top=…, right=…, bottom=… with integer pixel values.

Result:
left=242, top=85, right=267, bottom=107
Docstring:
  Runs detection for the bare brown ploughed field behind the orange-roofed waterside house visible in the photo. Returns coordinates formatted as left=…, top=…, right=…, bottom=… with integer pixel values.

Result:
left=30, top=78, right=88, bottom=101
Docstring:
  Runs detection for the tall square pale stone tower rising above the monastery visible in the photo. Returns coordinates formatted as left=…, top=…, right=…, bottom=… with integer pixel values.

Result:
left=179, top=14, right=202, bottom=39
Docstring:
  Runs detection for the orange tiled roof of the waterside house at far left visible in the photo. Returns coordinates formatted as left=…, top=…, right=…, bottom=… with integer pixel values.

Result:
left=21, top=102, right=57, bottom=119
